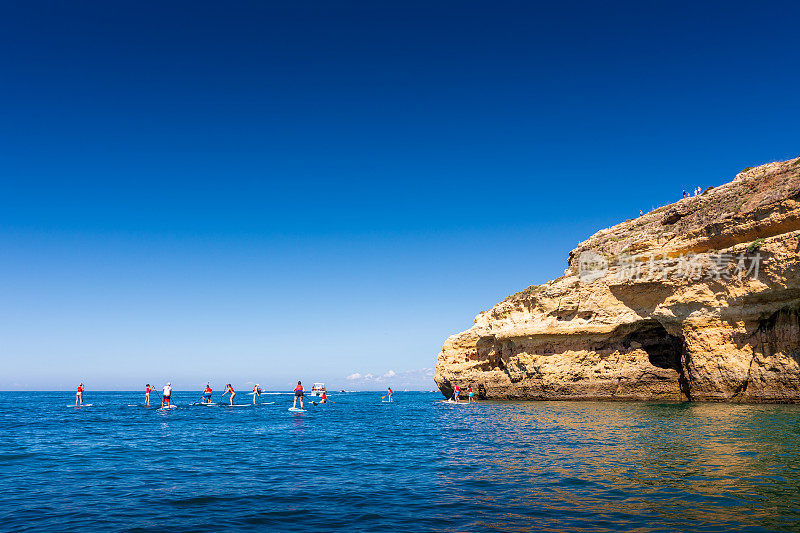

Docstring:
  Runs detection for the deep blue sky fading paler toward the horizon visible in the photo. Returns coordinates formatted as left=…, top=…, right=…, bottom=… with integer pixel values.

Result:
left=0, top=0, right=800, bottom=390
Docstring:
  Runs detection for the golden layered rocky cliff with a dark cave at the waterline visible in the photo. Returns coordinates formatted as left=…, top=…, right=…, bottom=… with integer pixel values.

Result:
left=435, top=158, right=800, bottom=402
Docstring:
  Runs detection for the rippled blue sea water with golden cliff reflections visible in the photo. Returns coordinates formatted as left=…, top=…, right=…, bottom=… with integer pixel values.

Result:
left=0, top=392, right=800, bottom=532
